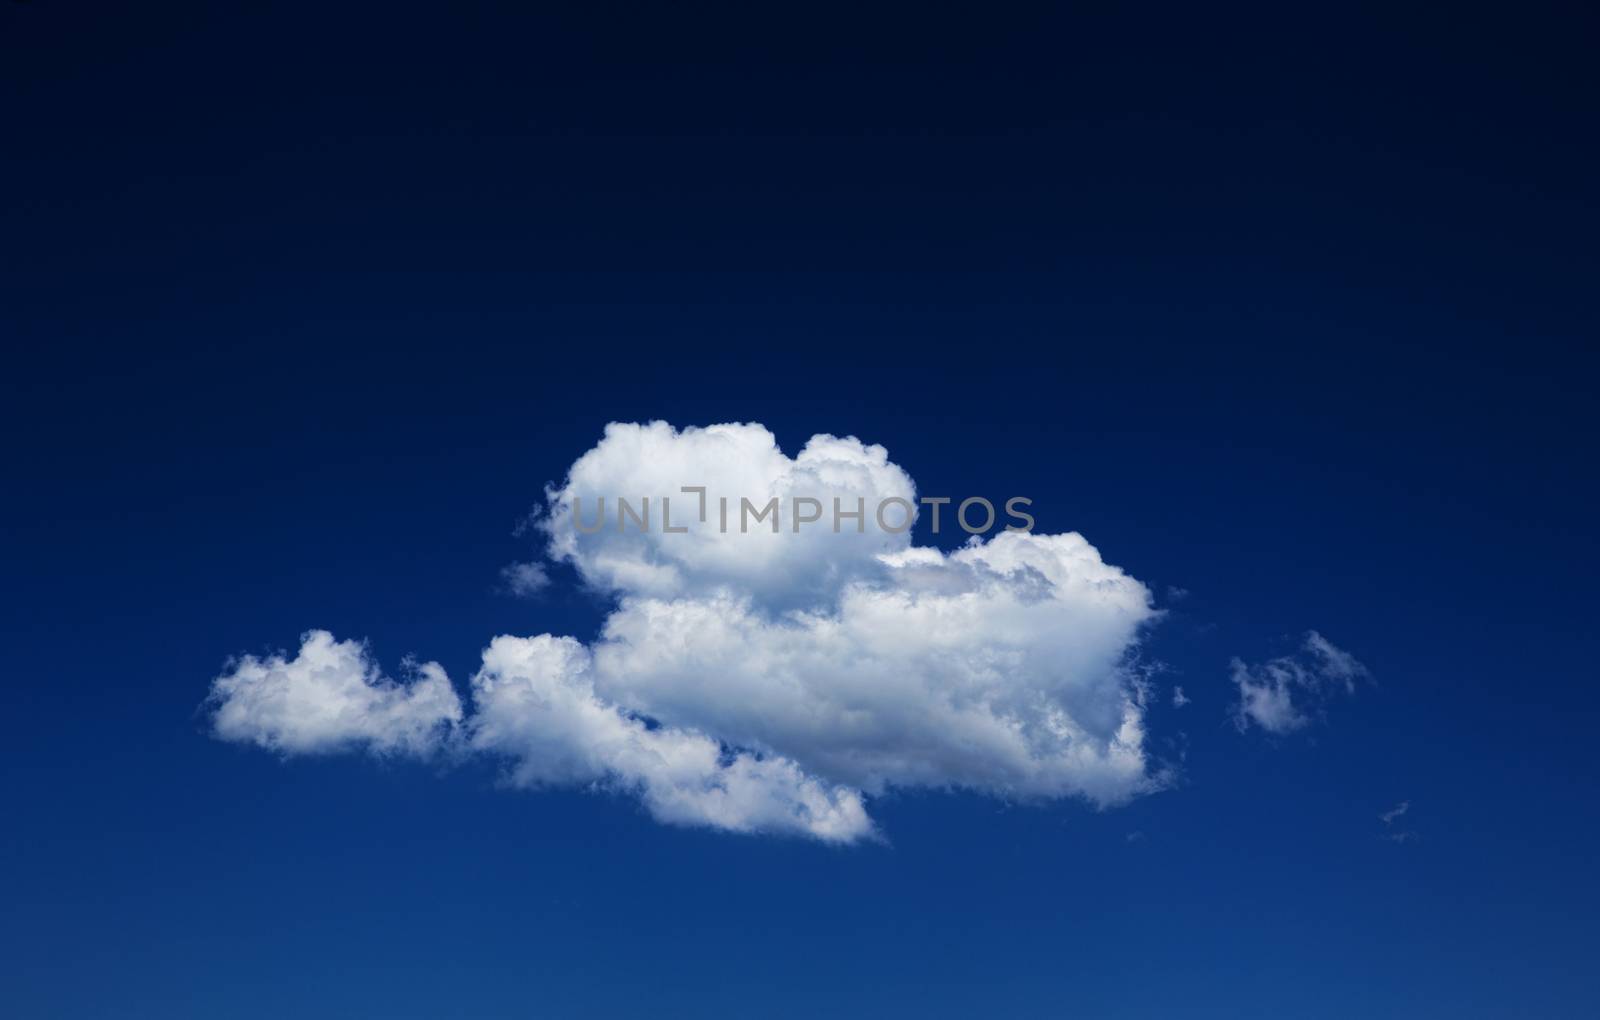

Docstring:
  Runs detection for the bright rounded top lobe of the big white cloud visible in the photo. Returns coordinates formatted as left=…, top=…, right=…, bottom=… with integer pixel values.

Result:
left=541, top=422, right=917, bottom=608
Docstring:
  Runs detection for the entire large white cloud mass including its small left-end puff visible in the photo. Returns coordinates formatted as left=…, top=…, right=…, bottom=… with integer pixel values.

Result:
left=210, top=422, right=1164, bottom=843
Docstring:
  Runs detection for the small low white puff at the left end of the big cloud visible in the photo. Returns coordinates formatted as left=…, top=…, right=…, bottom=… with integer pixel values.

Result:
left=210, top=630, right=461, bottom=755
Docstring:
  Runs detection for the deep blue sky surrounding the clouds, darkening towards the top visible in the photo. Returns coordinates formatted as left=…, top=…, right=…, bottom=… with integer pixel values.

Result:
left=0, top=2, right=1600, bottom=1018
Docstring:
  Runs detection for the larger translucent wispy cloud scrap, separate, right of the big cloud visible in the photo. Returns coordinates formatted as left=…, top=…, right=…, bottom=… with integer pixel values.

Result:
left=1230, top=630, right=1366, bottom=734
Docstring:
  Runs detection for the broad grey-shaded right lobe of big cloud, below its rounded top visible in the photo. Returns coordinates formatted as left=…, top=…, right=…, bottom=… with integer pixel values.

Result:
left=594, top=534, right=1150, bottom=804
